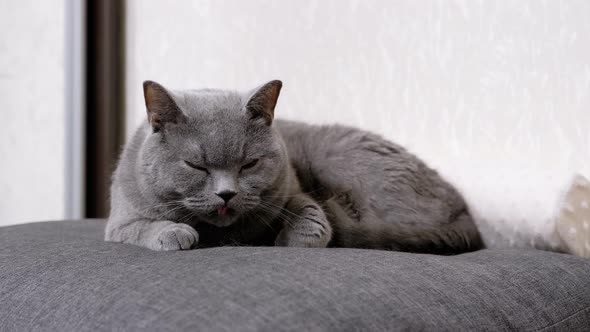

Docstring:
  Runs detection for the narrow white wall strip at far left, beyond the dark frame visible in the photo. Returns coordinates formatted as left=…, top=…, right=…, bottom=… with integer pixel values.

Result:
left=0, top=0, right=65, bottom=226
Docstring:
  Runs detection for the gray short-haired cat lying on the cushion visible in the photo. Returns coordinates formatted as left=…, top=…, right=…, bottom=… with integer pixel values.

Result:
left=105, top=81, right=482, bottom=254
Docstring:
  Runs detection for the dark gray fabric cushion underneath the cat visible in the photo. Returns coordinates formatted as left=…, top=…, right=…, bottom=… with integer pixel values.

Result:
left=0, top=220, right=590, bottom=331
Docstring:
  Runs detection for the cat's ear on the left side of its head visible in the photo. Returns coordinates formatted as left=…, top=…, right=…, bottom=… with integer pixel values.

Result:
left=143, top=81, right=186, bottom=132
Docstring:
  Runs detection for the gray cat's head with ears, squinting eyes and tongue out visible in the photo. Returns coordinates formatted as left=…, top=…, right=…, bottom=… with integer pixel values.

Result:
left=138, top=81, right=288, bottom=226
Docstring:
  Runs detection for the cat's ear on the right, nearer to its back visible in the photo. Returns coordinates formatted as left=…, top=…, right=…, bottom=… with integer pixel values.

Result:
left=246, top=80, right=283, bottom=125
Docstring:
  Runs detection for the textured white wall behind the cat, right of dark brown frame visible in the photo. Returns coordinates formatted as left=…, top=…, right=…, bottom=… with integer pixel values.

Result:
left=128, top=0, right=590, bottom=200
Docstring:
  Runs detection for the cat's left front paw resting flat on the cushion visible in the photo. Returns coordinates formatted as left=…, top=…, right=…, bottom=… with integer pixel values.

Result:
left=151, top=224, right=199, bottom=251
